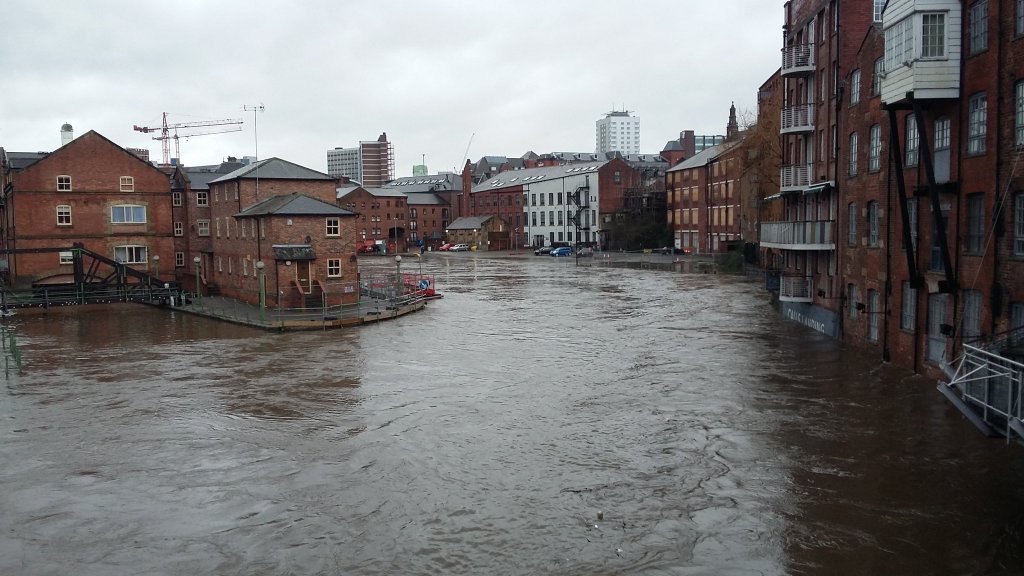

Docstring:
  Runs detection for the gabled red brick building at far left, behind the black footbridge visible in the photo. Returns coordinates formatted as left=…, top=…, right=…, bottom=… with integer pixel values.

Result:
left=7, top=131, right=174, bottom=282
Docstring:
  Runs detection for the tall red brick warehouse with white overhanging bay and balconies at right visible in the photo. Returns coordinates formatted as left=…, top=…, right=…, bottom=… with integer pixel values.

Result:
left=760, top=0, right=1024, bottom=376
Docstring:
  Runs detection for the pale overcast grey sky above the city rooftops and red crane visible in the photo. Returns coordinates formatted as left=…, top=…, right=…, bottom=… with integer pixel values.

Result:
left=0, top=0, right=783, bottom=176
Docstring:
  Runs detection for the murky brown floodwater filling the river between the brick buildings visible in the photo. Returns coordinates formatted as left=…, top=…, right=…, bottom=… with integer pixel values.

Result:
left=0, top=254, right=1024, bottom=576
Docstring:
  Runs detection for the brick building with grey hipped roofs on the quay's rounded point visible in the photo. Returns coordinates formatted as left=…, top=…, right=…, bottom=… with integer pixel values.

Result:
left=205, top=158, right=359, bottom=307
